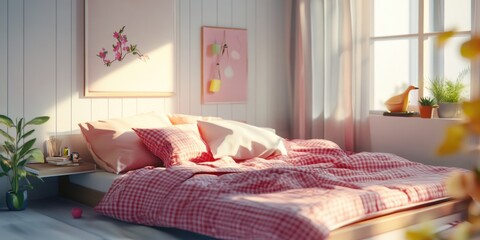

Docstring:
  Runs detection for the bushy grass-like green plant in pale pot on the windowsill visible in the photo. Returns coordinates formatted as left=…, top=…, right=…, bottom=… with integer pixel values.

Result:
left=429, top=68, right=470, bottom=118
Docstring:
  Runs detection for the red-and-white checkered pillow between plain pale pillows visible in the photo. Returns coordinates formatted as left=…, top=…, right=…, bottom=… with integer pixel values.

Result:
left=133, top=124, right=214, bottom=167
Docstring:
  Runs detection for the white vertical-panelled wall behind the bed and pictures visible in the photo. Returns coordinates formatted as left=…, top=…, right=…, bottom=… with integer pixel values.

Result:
left=0, top=0, right=288, bottom=202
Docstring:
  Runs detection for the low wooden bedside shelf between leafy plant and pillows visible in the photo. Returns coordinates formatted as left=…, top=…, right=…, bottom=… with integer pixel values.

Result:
left=25, top=162, right=97, bottom=178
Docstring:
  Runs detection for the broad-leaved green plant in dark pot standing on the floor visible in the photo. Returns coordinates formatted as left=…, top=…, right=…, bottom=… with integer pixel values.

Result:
left=0, top=114, right=50, bottom=210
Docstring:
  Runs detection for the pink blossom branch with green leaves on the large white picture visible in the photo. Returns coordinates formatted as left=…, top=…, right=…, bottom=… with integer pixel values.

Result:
left=97, top=26, right=149, bottom=67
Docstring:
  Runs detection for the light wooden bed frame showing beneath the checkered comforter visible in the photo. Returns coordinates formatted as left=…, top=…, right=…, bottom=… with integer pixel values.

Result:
left=59, top=176, right=469, bottom=240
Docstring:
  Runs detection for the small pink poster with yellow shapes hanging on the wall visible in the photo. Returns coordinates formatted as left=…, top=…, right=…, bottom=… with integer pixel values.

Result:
left=202, top=27, right=248, bottom=103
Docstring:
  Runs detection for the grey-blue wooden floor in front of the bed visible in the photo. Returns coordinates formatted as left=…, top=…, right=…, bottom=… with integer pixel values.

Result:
left=0, top=198, right=211, bottom=240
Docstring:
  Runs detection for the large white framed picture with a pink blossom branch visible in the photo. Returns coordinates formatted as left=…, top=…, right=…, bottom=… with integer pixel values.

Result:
left=84, top=0, right=175, bottom=97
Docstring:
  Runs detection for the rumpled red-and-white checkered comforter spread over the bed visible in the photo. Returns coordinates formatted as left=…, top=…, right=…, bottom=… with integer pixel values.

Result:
left=95, top=140, right=462, bottom=239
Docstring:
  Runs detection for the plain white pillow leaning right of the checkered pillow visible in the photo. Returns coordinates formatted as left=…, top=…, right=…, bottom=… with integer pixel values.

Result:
left=197, top=120, right=287, bottom=160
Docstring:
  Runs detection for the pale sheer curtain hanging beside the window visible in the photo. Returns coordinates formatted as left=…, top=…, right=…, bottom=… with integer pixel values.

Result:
left=290, top=0, right=370, bottom=151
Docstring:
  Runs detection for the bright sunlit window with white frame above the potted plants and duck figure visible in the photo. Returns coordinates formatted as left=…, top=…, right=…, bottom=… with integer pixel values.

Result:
left=370, top=0, right=477, bottom=111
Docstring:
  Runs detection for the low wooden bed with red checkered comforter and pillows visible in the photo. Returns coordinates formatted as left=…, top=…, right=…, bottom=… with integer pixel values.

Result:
left=61, top=113, right=468, bottom=239
